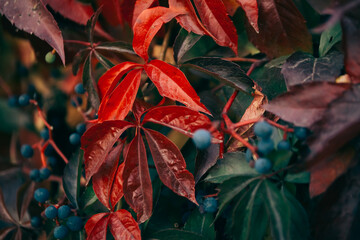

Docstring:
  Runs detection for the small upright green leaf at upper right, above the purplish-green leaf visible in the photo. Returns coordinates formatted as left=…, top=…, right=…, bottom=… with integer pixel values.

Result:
left=319, top=23, right=342, bottom=57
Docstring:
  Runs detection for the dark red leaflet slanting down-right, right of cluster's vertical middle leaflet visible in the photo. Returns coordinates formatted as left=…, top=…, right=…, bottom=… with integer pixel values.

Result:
left=144, top=129, right=197, bottom=204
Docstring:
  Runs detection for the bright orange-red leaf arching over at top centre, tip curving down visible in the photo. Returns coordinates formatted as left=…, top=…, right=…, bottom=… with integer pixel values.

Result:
left=133, top=7, right=181, bottom=62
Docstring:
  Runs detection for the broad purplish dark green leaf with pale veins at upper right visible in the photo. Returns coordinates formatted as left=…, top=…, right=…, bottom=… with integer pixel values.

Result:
left=281, top=51, right=344, bottom=89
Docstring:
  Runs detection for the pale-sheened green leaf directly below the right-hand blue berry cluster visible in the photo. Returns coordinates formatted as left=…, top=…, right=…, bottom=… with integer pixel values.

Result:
left=205, top=152, right=260, bottom=183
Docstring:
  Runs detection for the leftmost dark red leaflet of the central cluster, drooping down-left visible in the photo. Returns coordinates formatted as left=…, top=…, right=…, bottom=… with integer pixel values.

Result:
left=81, top=121, right=134, bottom=182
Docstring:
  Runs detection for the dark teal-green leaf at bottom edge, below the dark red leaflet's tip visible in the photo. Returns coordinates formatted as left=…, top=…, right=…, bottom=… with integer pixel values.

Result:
left=184, top=208, right=216, bottom=240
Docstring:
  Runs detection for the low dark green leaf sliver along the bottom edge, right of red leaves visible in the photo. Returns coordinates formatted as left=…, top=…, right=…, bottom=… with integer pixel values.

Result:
left=150, top=228, right=205, bottom=240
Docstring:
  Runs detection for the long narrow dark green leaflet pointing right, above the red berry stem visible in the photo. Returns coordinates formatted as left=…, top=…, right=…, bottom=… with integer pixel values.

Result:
left=184, top=57, right=254, bottom=94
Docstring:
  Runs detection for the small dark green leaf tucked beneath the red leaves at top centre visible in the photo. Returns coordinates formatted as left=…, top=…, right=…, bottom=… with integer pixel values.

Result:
left=174, top=28, right=202, bottom=63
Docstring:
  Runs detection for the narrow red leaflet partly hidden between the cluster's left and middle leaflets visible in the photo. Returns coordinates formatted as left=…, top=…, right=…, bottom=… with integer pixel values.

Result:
left=92, top=143, right=123, bottom=209
